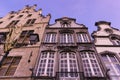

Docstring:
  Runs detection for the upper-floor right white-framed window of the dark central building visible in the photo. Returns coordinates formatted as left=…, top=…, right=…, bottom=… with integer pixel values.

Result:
left=77, top=33, right=90, bottom=43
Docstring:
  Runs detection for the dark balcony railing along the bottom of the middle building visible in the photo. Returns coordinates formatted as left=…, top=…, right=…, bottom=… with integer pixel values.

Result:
left=32, top=72, right=107, bottom=80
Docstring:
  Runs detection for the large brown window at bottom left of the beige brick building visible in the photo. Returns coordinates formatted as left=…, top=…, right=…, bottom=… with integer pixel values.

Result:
left=0, top=57, right=21, bottom=76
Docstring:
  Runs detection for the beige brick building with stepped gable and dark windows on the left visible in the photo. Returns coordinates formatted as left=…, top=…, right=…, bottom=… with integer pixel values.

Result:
left=0, top=5, right=50, bottom=80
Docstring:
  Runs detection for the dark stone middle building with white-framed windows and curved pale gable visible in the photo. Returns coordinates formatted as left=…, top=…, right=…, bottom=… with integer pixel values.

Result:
left=33, top=17, right=107, bottom=80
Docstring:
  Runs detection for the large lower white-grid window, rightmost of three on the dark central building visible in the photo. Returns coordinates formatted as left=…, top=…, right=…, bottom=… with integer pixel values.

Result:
left=80, top=52, right=102, bottom=77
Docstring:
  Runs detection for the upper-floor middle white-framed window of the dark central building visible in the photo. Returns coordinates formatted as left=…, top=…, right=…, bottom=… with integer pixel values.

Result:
left=60, top=33, right=74, bottom=43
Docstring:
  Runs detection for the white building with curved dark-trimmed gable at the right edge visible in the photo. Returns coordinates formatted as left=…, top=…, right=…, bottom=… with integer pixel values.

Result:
left=92, top=21, right=120, bottom=80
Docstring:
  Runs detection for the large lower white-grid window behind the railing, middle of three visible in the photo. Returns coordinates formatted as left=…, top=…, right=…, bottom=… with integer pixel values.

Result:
left=59, top=52, right=78, bottom=77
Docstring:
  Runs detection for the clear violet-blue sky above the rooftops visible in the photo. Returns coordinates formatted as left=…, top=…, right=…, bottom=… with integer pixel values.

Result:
left=0, top=0, right=120, bottom=33
